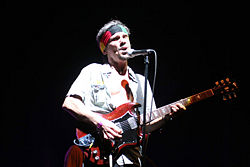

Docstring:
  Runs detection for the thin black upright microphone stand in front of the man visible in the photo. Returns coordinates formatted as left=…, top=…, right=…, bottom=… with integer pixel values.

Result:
left=142, top=54, right=149, bottom=167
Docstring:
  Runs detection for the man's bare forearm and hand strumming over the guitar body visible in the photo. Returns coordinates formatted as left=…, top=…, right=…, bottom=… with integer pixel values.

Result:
left=62, top=96, right=122, bottom=139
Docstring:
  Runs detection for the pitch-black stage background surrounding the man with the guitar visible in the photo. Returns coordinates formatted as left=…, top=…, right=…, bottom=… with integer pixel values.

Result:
left=0, top=1, right=245, bottom=167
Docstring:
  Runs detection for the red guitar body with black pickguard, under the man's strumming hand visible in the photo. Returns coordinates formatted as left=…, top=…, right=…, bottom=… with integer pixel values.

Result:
left=76, top=102, right=140, bottom=165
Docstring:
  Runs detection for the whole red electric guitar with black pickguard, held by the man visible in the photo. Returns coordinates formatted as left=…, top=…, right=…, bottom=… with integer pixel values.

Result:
left=75, top=78, right=238, bottom=165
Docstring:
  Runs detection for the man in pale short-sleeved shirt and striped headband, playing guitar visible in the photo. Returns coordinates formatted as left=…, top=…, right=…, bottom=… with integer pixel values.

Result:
left=63, top=20, right=185, bottom=167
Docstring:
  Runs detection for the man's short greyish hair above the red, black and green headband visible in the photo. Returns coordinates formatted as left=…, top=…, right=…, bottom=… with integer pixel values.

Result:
left=96, top=20, right=130, bottom=46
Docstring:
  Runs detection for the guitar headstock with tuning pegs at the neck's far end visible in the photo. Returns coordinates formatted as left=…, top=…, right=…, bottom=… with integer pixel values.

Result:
left=213, top=78, right=238, bottom=100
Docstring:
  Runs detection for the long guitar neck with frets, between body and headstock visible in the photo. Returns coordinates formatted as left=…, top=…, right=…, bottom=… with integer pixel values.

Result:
left=140, top=89, right=214, bottom=124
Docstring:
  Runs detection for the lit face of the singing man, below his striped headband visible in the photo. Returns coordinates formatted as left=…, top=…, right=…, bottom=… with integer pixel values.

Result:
left=105, top=32, right=131, bottom=63
